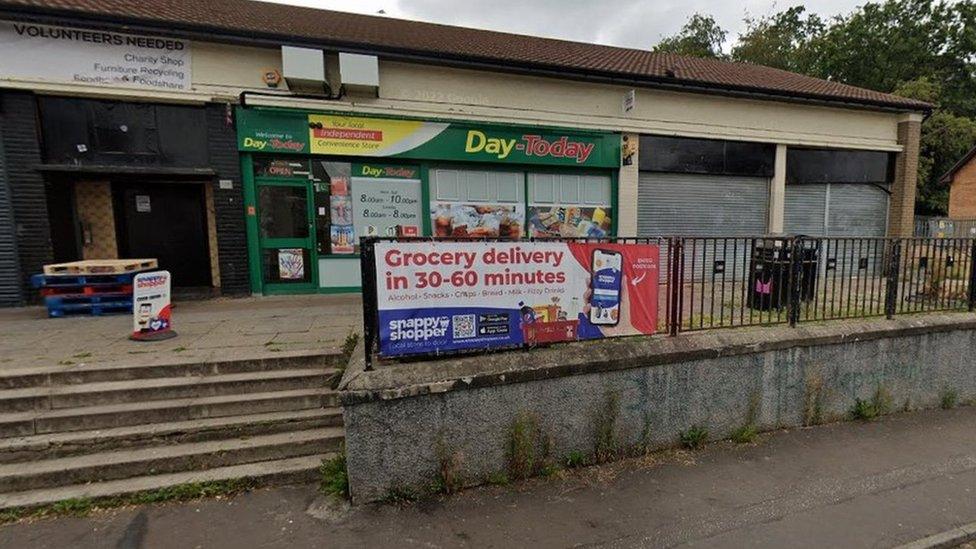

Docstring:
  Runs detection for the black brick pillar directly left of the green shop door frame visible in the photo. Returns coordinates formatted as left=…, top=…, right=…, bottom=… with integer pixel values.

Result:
left=207, top=100, right=251, bottom=295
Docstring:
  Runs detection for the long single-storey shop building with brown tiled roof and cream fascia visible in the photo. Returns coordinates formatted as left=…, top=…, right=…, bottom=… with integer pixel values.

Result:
left=0, top=0, right=930, bottom=305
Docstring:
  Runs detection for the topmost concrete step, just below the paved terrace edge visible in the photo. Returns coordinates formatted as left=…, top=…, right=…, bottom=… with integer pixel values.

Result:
left=0, top=351, right=342, bottom=390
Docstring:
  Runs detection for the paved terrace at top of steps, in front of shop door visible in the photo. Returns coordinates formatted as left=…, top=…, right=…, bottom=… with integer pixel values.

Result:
left=0, top=295, right=362, bottom=369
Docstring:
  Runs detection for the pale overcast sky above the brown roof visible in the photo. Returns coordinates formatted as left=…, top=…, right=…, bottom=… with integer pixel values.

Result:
left=271, top=0, right=864, bottom=49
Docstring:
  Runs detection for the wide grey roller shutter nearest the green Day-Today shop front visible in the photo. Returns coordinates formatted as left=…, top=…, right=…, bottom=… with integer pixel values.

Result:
left=637, top=172, right=769, bottom=236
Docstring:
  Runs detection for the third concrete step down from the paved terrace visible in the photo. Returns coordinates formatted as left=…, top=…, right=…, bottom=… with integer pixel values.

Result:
left=0, top=388, right=339, bottom=437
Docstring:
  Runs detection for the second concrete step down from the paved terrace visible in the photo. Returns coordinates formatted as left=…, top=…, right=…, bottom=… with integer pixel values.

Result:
left=0, top=368, right=335, bottom=413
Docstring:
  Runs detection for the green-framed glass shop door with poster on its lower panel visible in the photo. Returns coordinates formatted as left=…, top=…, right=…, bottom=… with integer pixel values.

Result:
left=257, top=180, right=318, bottom=294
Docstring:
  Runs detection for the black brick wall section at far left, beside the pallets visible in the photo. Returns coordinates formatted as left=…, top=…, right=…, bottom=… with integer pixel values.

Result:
left=0, top=92, right=52, bottom=297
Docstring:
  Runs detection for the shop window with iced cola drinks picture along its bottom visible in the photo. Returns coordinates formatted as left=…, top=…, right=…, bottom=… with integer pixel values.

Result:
left=430, top=169, right=525, bottom=238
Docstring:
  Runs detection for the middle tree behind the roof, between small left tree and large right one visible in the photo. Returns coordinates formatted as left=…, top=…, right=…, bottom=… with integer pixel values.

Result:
left=732, top=6, right=825, bottom=73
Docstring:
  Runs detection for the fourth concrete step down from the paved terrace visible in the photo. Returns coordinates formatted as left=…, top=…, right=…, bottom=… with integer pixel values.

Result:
left=0, top=408, right=342, bottom=463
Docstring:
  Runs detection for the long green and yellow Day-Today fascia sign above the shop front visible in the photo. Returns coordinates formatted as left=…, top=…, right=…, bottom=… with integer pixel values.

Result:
left=237, top=109, right=620, bottom=168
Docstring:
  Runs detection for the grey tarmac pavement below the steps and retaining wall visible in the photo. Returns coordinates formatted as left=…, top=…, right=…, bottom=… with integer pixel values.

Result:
left=0, top=407, right=976, bottom=549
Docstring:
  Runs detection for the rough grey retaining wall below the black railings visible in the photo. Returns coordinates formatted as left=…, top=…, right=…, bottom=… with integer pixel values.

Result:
left=340, top=314, right=976, bottom=503
